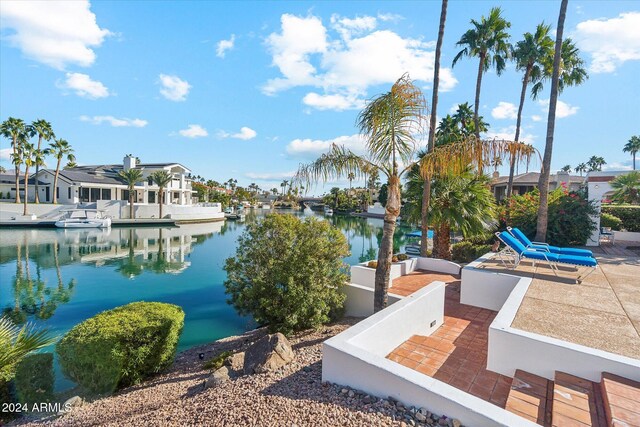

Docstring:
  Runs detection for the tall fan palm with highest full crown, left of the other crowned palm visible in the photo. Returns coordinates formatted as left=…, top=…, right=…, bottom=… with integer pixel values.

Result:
left=452, top=7, right=511, bottom=155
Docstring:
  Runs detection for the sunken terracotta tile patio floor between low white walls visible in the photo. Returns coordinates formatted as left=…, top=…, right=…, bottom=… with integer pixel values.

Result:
left=387, top=282, right=511, bottom=408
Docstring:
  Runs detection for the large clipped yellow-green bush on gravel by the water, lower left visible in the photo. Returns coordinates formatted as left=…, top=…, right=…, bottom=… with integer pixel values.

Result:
left=56, top=302, right=184, bottom=393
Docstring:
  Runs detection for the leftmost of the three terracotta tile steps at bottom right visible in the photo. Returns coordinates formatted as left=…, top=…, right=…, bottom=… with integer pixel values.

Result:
left=505, top=370, right=553, bottom=426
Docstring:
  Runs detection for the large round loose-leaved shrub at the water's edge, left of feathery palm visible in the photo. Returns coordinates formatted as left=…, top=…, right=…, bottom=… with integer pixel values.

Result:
left=224, top=214, right=349, bottom=334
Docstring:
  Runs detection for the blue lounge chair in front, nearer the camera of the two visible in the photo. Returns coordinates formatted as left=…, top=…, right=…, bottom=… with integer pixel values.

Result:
left=496, top=231, right=598, bottom=283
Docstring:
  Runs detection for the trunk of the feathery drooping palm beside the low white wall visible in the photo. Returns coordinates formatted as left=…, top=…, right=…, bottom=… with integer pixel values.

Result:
left=373, top=176, right=400, bottom=312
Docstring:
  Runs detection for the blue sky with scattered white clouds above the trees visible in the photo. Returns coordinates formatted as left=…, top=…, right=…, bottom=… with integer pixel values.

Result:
left=0, top=0, right=640, bottom=194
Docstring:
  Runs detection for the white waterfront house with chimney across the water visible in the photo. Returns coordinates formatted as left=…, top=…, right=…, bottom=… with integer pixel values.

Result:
left=24, top=156, right=192, bottom=205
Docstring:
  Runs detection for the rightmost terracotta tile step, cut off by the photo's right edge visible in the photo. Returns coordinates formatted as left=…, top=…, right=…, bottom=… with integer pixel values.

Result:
left=600, top=372, right=640, bottom=427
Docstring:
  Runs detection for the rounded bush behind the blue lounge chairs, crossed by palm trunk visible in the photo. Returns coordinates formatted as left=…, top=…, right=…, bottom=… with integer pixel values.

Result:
left=500, top=187, right=597, bottom=246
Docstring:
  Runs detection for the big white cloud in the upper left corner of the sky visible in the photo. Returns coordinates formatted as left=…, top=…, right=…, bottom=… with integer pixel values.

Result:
left=0, top=0, right=111, bottom=70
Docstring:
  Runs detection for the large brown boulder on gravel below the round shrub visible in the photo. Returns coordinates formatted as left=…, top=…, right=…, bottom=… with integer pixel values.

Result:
left=244, top=333, right=295, bottom=375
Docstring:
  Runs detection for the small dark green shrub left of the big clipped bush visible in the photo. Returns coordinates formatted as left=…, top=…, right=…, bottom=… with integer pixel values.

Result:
left=14, top=353, right=54, bottom=406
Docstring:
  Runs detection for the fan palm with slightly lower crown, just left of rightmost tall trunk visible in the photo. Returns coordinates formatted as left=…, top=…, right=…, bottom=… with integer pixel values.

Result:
left=506, top=23, right=553, bottom=201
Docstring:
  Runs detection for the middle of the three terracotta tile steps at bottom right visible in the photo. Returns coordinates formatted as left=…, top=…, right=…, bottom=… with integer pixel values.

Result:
left=551, top=372, right=606, bottom=427
